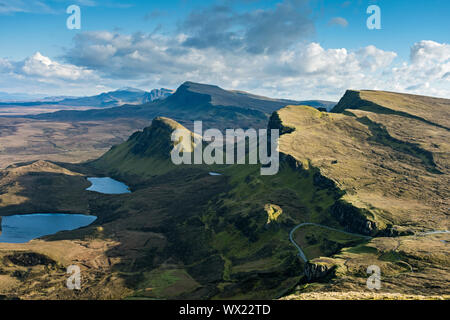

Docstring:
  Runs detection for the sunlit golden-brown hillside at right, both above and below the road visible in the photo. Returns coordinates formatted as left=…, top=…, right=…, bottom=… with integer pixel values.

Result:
left=277, top=91, right=450, bottom=299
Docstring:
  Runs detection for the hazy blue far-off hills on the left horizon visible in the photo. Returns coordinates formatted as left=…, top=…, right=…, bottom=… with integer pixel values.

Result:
left=0, top=87, right=174, bottom=108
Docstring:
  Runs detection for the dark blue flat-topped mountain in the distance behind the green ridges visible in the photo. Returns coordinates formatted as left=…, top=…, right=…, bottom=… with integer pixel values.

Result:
left=31, top=82, right=336, bottom=128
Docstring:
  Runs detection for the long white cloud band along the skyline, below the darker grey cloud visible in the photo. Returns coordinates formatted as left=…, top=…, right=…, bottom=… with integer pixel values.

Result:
left=0, top=32, right=450, bottom=100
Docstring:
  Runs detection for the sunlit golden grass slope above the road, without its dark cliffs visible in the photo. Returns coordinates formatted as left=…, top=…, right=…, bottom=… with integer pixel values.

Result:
left=278, top=99, right=450, bottom=234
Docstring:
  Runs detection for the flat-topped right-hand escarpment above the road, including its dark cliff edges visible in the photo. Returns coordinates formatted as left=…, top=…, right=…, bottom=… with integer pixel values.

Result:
left=272, top=92, right=450, bottom=234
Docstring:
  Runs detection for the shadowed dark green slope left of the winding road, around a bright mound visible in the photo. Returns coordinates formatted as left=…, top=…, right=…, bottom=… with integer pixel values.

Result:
left=198, top=163, right=340, bottom=298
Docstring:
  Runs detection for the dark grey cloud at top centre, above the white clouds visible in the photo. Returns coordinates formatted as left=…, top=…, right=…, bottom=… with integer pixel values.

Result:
left=179, top=0, right=314, bottom=54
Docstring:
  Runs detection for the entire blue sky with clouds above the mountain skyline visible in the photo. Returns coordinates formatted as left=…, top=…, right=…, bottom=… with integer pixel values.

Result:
left=0, top=0, right=450, bottom=101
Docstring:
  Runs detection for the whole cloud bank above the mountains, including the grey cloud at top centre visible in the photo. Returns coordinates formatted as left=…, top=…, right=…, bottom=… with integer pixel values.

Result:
left=0, top=0, right=450, bottom=100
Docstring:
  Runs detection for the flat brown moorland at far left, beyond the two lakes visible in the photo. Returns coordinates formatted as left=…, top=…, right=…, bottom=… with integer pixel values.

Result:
left=0, top=117, right=149, bottom=168
